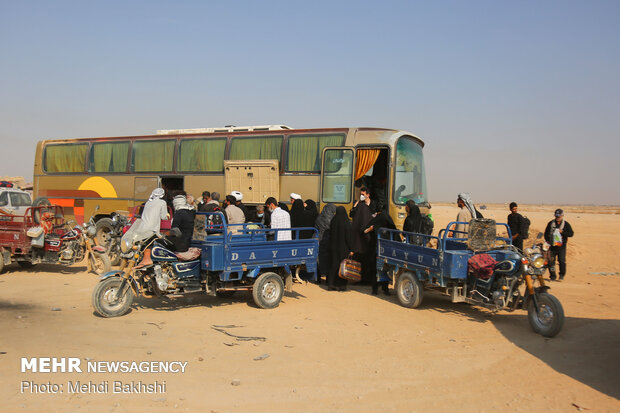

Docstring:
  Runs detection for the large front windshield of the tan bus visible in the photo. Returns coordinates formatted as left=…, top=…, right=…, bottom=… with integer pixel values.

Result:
left=393, top=136, right=428, bottom=205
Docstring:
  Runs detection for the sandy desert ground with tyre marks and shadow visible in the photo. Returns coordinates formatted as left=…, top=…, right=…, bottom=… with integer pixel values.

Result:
left=0, top=204, right=620, bottom=412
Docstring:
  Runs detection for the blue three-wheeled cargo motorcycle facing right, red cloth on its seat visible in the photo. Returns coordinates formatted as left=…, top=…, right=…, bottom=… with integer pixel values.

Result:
left=377, top=219, right=564, bottom=337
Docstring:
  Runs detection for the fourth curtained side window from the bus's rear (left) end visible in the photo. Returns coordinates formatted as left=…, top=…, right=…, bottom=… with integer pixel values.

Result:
left=177, top=138, right=226, bottom=172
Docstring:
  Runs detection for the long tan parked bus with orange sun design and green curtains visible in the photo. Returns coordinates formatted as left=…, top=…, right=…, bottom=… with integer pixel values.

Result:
left=33, top=125, right=428, bottom=225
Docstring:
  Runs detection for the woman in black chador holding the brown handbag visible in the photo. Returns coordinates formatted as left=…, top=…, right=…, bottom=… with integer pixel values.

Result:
left=327, top=206, right=351, bottom=291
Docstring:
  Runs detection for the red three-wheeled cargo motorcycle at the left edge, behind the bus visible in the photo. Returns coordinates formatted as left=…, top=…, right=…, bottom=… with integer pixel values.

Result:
left=0, top=205, right=110, bottom=274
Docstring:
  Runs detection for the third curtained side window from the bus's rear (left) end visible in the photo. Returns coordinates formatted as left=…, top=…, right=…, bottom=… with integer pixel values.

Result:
left=131, top=139, right=175, bottom=172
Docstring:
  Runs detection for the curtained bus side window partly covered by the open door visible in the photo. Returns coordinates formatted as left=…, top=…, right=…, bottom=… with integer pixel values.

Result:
left=286, top=134, right=344, bottom=172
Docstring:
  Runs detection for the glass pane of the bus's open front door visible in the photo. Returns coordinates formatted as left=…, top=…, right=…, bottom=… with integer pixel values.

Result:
left=321, top=149, right=353, bottom=204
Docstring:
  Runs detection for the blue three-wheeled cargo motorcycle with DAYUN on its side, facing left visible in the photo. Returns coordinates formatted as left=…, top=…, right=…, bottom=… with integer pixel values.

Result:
left=92, top=212, right=318, bottom=317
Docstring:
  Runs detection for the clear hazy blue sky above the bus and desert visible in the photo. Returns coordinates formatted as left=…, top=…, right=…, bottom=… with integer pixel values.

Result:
left=0, top=0, right=620, bottom=205
